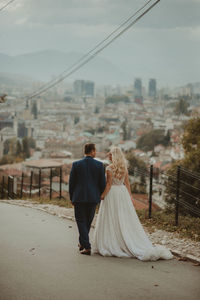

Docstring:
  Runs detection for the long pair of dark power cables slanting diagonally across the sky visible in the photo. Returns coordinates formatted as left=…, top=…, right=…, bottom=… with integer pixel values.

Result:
left=25, top=0, right=160, bottom=100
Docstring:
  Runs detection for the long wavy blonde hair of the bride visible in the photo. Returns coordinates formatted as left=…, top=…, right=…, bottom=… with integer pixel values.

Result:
left=110, top=147, right=127, bottom=179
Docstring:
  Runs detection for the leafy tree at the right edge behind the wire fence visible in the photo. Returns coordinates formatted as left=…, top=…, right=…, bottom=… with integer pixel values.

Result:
left=166, top=117, right=200, bottom=216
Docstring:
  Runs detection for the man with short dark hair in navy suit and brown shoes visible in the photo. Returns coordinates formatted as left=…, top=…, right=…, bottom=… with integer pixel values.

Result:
left=69, top=144, right=105, bottom=255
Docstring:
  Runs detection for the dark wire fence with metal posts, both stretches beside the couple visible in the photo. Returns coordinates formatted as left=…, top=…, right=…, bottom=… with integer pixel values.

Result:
left=0, top=165, right=200, bottom=225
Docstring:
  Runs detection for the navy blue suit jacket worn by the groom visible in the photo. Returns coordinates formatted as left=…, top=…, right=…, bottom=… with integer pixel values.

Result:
left=69, top=156, right=106, bottom=204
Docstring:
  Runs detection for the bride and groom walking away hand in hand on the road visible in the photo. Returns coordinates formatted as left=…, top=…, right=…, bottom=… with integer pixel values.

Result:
left=69, top=144, right=173, bottom=261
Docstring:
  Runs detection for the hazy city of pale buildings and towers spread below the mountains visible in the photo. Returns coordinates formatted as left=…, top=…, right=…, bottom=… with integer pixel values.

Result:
left=0, top=78, right=200, bottom=207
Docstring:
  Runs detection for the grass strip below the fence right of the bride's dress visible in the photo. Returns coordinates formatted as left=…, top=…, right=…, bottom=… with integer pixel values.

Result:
left=137, top=210, right=200, bottom=241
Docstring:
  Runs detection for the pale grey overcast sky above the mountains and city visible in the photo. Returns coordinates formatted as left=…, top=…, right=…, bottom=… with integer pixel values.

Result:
left=0, top=0, right=200, bottom=86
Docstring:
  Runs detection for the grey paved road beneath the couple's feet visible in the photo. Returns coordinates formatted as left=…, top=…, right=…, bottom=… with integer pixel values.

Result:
left=0, top=203, right=200, bottom=300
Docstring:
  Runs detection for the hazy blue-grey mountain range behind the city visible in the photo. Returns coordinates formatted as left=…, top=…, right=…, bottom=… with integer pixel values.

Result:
left=0, top=50, right=130, bottom=84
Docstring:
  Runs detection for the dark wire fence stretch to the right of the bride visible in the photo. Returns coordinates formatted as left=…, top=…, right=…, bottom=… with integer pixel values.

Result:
left=129, top=165, right=200, bottom=225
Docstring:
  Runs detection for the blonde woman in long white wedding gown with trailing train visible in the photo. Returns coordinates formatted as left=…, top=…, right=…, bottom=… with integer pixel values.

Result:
left=93, top=147, right=173, bottom=261
